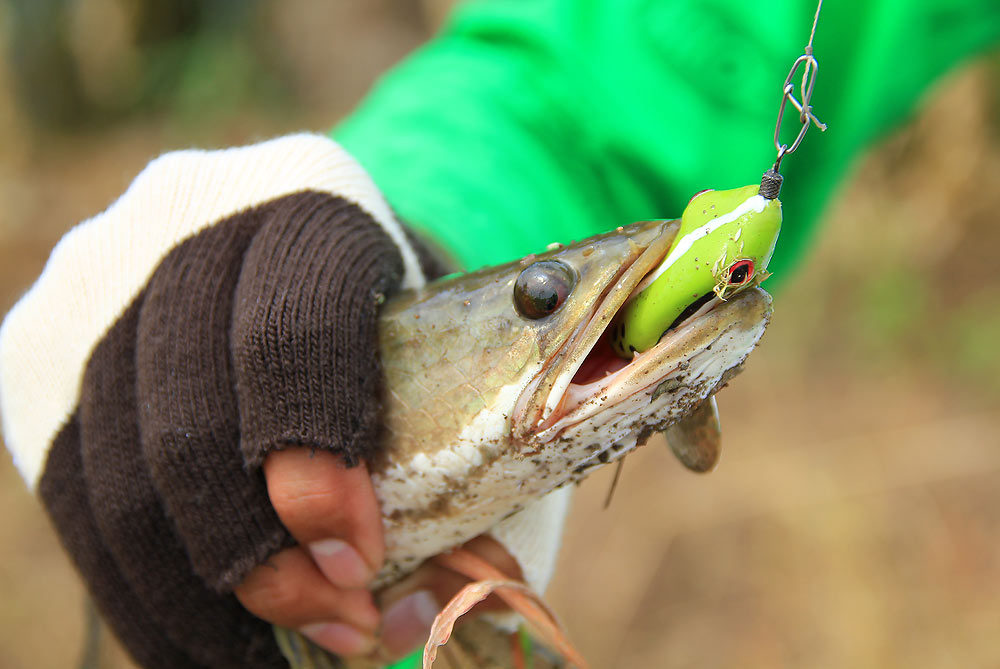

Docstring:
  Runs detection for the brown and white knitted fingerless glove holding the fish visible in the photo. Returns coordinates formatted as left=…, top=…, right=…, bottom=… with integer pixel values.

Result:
left=0, top=135, right=442, bottom=667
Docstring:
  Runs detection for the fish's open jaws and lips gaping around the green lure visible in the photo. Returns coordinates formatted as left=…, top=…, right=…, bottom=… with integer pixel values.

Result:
left=514, top=224, right=771, bottom=447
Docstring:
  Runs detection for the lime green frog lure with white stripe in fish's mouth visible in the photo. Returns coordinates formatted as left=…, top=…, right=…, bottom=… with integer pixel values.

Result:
left=611, top=185, right=781, bottom=358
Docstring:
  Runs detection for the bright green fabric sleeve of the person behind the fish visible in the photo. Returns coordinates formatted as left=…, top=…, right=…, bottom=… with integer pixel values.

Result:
left=334, top=0, right=1000, bottom=276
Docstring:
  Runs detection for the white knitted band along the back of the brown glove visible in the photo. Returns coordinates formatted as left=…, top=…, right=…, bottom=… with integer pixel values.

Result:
left=0, top=134, right=424, bottom=488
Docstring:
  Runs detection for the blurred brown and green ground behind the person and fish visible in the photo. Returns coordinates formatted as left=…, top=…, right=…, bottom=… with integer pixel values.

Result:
left=0, top=0, right=1000, bottom=669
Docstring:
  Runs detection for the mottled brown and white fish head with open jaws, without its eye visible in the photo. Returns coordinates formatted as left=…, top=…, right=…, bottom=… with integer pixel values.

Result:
left=371, top=221, right=771, bottom=585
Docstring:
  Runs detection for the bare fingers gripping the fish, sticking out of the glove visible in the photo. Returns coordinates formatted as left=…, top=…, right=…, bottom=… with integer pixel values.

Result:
left=235, top=448, right=520, bottom=659
